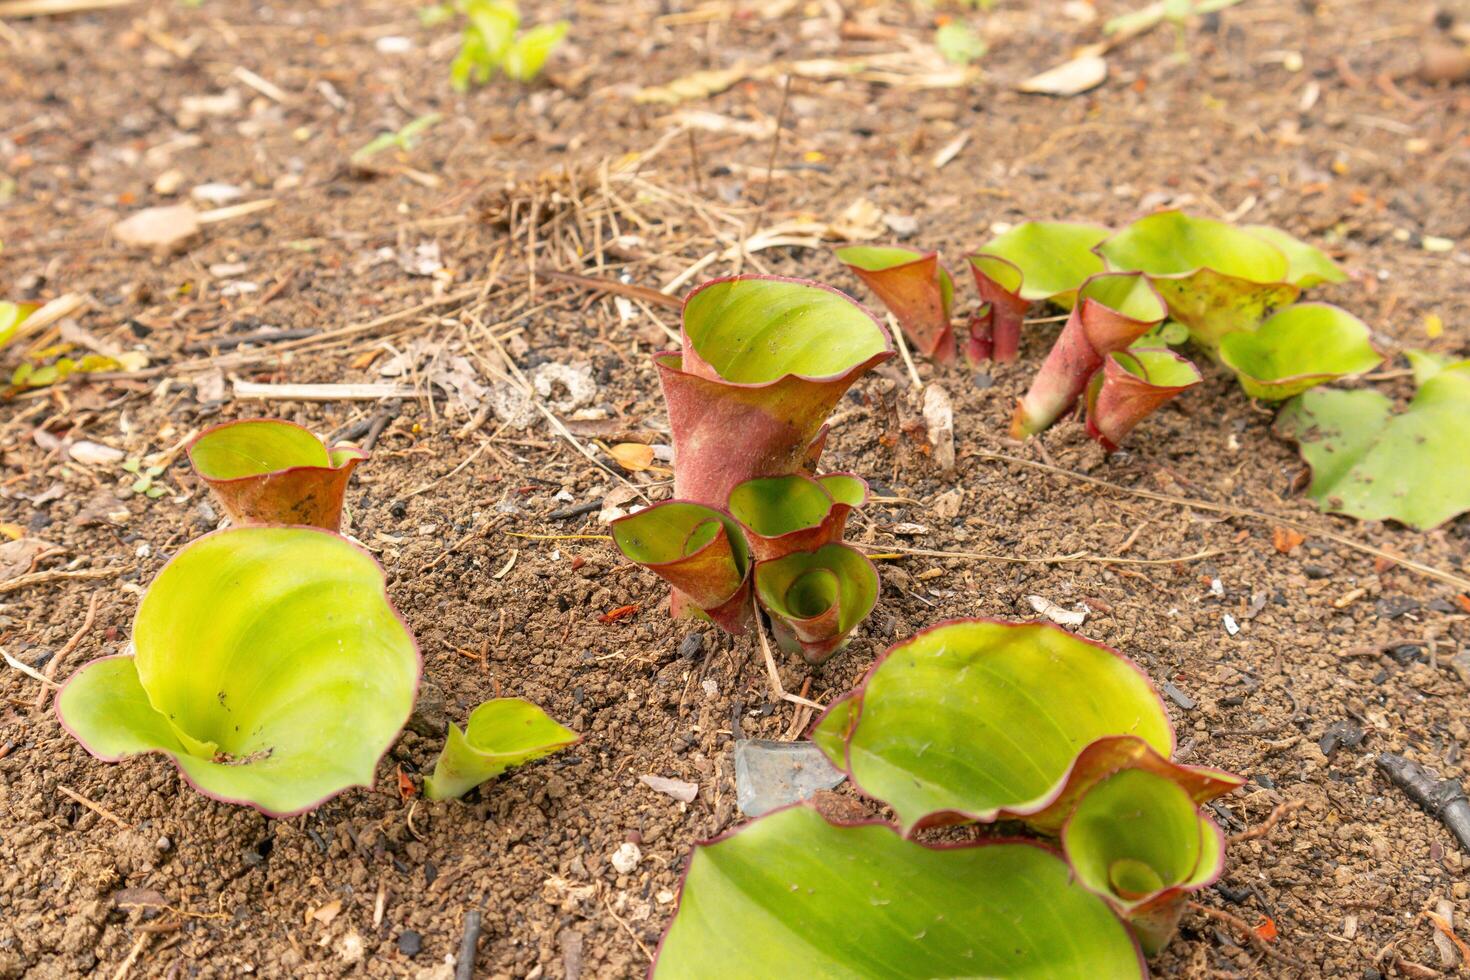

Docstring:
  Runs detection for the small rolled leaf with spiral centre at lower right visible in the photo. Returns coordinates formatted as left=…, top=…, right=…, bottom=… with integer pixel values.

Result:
left=1061, top=768, right=1225, bottom=956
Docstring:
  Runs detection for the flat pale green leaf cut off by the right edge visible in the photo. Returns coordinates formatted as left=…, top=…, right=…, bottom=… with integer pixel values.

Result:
left=1277, top=361, right=1470, bottom=530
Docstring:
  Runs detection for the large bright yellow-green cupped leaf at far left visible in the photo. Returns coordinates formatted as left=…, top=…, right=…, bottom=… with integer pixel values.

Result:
left=56, top=527, right=420, bottom=817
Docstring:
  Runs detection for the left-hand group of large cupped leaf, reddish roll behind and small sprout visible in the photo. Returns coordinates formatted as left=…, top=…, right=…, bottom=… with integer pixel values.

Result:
left=56, top=419, right=576, bottom=817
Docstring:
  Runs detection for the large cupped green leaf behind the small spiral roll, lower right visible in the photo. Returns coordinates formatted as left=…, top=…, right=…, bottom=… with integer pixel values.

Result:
left=813, top=620, right=1173, bottom=832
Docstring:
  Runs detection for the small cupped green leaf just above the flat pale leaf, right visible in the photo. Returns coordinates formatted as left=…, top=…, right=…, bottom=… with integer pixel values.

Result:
left=1220, top=303, right=1383, bottom=401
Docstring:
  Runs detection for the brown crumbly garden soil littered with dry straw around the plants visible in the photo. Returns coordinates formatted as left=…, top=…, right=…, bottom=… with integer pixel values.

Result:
left=0, top=0, right=1470, bottom=979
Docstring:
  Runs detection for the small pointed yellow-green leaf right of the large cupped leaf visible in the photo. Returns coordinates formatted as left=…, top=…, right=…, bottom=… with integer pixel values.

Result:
left=423, top=698, right=578, bottom=799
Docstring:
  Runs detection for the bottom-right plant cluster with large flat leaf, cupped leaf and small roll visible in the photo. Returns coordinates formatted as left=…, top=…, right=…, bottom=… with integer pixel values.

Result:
left=654, top=620, right=1242, bottom=979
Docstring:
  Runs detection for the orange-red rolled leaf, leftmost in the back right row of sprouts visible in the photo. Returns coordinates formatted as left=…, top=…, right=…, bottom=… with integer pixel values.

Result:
left=836, top=245, right=954, bottom=361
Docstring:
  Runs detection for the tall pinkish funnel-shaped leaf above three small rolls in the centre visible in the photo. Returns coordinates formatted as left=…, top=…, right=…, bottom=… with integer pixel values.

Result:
left=667, top=276, right=894, bottom=507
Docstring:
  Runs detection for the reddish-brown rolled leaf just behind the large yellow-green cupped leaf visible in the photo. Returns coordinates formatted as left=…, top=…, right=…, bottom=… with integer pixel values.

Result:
left=188, top=419, right=368, bottom=530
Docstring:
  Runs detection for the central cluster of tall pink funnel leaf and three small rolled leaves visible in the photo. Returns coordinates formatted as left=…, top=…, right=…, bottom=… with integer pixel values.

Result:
left=613, top=276, right=894, bottom=663
